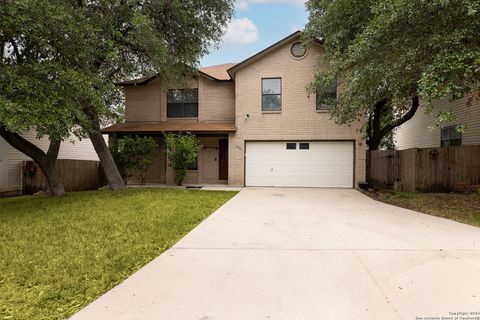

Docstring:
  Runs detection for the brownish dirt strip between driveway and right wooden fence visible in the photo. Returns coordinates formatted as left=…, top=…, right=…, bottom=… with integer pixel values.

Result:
left=366, top=190, right=480, bottom=227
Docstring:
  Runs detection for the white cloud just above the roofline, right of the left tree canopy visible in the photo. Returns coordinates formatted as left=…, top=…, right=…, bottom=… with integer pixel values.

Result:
left=222, top=18, right=258, bottom=48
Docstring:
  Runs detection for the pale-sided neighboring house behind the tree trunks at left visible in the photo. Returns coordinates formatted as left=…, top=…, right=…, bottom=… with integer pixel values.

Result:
left=0, top=132, right=102, bottom=195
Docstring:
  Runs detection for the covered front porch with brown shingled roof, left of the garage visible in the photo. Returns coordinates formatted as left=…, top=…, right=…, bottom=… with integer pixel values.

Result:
left=103, top=122, right=235, bottom=187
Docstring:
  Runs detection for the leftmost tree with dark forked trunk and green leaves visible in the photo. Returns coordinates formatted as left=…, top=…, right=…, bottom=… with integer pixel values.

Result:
left=0, top=1, right=94, bottom=195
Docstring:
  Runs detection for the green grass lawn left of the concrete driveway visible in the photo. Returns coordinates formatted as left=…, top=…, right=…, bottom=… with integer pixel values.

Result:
left=0, top=189, right=236, bottom=320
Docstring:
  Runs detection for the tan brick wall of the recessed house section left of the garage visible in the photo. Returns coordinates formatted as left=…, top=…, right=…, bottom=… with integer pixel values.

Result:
left=125, top=77, right=235, bottom=185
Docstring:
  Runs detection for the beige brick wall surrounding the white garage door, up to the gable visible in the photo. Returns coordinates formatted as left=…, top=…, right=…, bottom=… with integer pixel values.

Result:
left=229, top=44, right=365, bottom=185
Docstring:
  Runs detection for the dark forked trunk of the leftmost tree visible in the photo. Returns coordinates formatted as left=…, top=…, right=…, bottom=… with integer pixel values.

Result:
left=0, top=124, right=65, bottom=196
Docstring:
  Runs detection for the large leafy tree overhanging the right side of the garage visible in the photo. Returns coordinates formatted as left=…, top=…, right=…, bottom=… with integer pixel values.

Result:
left=306, top=0, right=480, bottom=150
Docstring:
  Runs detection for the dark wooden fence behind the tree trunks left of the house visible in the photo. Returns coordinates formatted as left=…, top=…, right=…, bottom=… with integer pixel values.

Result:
left=23, top=159, right=105, bottom=194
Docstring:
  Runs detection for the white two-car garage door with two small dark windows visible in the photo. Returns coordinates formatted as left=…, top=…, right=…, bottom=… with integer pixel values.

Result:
left=245, top=141, right=353, bottom=188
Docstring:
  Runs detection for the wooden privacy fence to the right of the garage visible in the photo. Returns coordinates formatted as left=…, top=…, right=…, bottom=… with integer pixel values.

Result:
left=367, top=145, right=480, bottom=192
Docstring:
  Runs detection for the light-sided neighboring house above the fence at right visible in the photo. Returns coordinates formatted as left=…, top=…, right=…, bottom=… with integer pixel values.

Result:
left=395, top=97, right=480, bottom=150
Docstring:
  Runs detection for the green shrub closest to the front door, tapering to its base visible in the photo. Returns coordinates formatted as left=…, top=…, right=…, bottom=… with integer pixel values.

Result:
left=165, top=132, right=201, bottom=185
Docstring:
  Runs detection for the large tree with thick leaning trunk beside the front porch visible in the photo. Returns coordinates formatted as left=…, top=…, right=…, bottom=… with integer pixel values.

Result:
left=0, top=0, right=233, bottom=194
